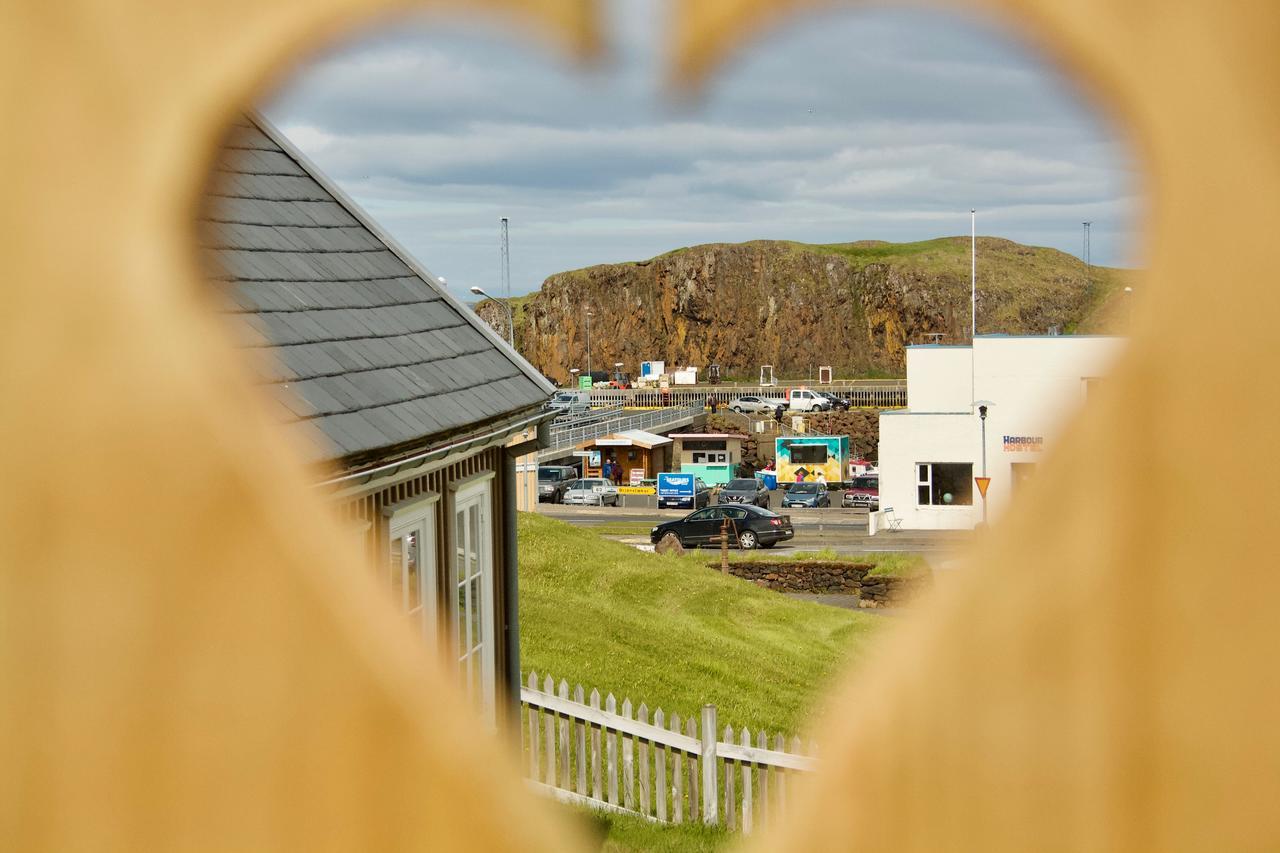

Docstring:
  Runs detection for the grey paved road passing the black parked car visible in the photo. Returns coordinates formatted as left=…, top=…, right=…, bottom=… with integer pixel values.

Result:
left=539, top=503, right=969, bottom=561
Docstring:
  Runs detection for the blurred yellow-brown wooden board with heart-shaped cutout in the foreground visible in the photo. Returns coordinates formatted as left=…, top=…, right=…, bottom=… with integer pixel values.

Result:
left=0, top=0, right=1280, bottom=850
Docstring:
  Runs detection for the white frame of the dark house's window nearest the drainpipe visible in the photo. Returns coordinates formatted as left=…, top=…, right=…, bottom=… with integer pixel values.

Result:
left=448, top=473, right=498, bottom=725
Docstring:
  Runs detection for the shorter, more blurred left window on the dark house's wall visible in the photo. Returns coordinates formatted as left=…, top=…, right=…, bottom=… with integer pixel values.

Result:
left=385, top=497, right=438, bottom=642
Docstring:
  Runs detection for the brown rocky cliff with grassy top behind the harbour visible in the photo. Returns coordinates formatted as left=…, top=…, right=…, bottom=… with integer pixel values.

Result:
left=479, top=237, right=1125, bottom=382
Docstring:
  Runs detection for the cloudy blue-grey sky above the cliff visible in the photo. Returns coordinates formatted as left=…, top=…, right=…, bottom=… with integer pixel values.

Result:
left=262, top=0, right=1140, bottom=296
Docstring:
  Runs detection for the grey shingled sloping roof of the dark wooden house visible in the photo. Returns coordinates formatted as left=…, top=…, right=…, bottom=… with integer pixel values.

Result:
left=202, top=113, right=552, bottom=461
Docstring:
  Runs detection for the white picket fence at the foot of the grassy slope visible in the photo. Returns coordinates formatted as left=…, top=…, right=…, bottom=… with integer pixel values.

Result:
left=520, top=672, right=814, bottom=833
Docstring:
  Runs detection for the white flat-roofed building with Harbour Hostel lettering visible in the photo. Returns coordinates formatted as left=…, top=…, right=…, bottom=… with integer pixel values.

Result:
left=879, top=336, right=1124, bottom=529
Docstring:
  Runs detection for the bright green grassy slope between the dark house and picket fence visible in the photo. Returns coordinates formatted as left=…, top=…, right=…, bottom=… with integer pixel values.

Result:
left=520, top=514, right=883, bottom=733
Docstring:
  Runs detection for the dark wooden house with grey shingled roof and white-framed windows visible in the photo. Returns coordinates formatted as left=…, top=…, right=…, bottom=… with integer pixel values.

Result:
left=201, top=117, right=554, bottom=720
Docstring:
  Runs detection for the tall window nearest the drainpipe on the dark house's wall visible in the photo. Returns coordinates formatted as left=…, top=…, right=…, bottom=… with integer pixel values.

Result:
left=449, top=480, right=497, bottom=720
